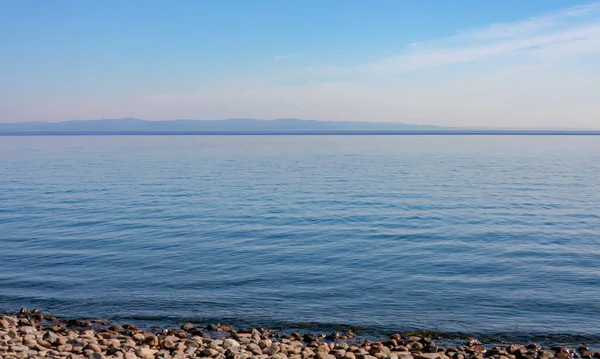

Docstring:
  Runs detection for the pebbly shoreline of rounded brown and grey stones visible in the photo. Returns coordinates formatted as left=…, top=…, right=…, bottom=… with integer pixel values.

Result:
left=0, top=308, right=600, bottom=359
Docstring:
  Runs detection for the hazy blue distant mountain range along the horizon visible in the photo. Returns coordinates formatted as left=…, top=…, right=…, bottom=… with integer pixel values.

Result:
left=0, top=118, right=596, bottom=134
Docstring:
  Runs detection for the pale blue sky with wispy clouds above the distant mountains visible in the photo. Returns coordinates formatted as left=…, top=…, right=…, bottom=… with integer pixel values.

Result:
left=0, top=0, right=600, bottom=128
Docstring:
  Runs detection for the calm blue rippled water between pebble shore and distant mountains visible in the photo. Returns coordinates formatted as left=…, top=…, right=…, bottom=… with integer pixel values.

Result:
left=0, top=136, right=600, bottom=334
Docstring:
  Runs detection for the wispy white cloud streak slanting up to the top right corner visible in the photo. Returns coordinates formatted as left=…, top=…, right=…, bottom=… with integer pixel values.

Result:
left=362, top=3, right=600, bottom=74
